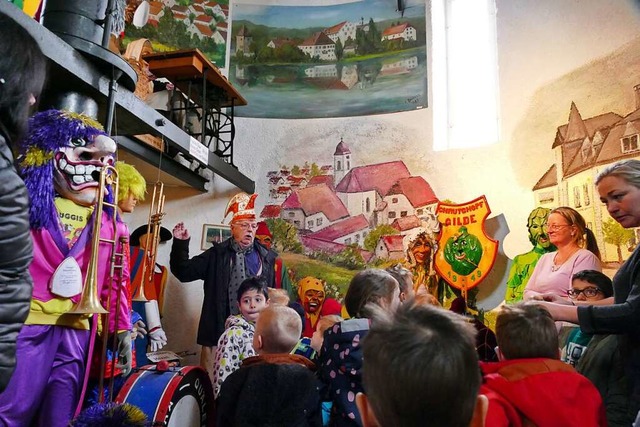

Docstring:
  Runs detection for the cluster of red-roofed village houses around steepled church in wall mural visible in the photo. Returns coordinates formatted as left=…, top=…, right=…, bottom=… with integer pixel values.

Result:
left=261, top=138, right=438, bottom=259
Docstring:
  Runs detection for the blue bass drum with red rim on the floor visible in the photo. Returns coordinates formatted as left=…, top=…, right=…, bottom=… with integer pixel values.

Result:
left=115, top=365, right=213, bottom=427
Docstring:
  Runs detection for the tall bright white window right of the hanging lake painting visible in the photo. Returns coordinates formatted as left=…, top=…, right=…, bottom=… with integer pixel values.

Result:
left=431, top=0, right=500, bottom=151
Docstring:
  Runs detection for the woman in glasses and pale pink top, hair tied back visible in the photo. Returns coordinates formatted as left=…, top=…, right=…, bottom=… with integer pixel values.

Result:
left=524, top=206, right=602, bottom=300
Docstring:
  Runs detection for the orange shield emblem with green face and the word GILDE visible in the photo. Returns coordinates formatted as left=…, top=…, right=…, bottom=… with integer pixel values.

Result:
left=435, top=196, right=498, bottom=292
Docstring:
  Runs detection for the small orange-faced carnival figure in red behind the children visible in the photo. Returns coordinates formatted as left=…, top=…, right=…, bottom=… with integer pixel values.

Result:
left=298, top=276, right=342, bottom=338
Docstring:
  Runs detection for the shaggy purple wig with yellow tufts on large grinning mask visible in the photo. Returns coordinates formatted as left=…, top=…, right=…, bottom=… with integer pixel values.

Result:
left=18, top=110, right=113, bottom=229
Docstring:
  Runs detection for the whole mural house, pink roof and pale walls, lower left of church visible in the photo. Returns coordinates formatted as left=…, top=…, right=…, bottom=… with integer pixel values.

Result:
left=280, top=185, right=349, bottom=232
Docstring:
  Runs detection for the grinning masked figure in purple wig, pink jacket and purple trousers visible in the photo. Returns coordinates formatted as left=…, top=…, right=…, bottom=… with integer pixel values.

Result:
left=0, top=110, right=131, bottom=427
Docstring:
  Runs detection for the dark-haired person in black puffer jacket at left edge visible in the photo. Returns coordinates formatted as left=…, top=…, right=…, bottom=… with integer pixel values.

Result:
left=0, top=13, right=46, bottom=392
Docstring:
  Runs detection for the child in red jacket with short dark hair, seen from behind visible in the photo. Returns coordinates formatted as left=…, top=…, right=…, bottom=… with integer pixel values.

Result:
left=480, top=304, right=607, bottom=427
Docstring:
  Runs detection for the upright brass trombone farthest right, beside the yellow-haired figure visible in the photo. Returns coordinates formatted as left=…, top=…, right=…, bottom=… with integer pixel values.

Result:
left=132, top=181, right=165, bottom=301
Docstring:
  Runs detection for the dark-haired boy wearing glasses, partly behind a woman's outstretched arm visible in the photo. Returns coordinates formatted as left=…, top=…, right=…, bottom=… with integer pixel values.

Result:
left=559, top=270, right=633, bottom=426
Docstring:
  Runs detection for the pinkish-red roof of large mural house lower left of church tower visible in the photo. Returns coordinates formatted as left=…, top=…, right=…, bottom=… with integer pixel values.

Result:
left=282, top=185, right=349, bottom=221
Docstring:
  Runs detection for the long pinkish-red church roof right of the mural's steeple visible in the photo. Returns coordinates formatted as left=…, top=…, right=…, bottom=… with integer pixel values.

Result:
left=336, top=160, right=411, bottom=195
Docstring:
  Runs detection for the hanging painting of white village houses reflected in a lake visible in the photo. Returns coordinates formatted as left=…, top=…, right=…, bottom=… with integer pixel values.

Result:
left=229, top=0, right=427, bottom=119
